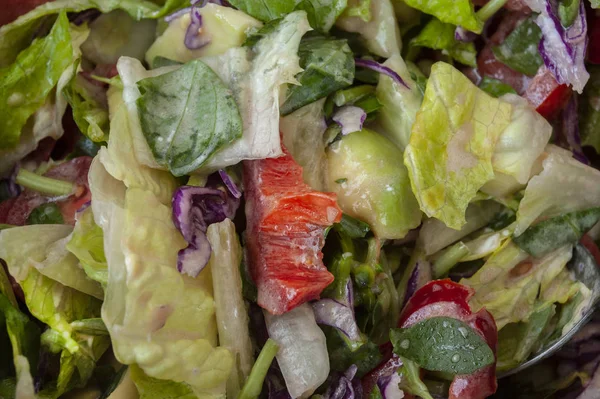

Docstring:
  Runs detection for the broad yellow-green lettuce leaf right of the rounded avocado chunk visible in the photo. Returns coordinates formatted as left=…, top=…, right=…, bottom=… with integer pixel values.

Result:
left=404, top=62, right=512, bottom=230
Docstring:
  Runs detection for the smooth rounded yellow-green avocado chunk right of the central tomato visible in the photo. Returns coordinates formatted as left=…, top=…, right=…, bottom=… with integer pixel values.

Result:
left=327, top=129, right=421, bottom=238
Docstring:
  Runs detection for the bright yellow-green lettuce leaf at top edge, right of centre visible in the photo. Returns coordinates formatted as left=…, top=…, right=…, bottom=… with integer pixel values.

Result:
left=405, top=0, right=483, bottom=33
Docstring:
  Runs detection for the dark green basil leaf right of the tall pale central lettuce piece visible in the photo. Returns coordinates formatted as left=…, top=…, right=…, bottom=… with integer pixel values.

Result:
left=281, top=36, right=354, bottom=115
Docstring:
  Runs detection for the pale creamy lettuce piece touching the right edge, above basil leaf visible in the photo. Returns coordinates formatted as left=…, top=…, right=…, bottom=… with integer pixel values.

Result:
left=515, top=145, right=600, bottom=236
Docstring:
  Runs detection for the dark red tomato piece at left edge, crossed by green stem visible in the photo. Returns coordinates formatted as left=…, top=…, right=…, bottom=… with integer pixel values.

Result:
left=0, top=157, right=92, bottom=226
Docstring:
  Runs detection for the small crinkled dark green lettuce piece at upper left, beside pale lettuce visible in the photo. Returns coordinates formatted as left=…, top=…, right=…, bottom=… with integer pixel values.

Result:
left=63, top=74, right=108, bottom=143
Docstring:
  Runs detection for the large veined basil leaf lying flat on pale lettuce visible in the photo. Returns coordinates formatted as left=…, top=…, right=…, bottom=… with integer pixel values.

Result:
left=137, top=60, right=242, bottom=176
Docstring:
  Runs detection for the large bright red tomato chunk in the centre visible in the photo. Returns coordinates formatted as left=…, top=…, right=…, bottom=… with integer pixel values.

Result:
left=244, top=148, right=342, bottom=314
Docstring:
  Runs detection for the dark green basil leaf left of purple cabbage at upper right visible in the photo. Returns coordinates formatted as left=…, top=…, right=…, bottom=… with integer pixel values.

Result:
left=492, top=17, right=544, bottom=76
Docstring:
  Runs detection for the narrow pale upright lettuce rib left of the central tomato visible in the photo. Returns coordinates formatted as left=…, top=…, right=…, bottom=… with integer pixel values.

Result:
left=206, top=219, right=252, bottom=397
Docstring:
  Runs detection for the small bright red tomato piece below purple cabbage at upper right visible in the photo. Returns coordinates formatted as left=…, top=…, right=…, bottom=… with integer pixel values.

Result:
left=523, top=68, right=572, bottom=119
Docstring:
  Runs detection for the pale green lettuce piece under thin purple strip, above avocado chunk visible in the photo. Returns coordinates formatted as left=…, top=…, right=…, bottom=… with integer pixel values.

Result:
left=376, top=55, right=423, bottom=150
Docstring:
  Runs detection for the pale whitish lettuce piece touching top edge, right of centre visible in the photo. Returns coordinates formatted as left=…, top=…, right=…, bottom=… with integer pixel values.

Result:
left=336, top=0, right=402, bottom=58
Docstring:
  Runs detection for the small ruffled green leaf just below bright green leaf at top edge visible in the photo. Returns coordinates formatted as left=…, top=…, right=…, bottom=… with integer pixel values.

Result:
left=410, top=18, right=477, bottom=67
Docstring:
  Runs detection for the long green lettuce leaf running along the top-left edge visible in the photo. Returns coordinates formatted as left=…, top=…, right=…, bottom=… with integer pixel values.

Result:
left=0, top=0, right=189, bottom=67
